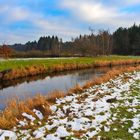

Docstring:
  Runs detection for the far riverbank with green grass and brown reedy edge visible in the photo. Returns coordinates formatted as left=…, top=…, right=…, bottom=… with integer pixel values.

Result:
left=0, top=56, right=140, bottom=81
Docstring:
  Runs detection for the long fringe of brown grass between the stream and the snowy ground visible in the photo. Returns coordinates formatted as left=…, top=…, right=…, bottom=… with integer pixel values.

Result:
left=0, top=62, right=140, bottom=129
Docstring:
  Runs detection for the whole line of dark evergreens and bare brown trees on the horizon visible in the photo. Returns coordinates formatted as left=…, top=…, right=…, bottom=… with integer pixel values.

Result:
left=0, top=24, right=140, bottom=56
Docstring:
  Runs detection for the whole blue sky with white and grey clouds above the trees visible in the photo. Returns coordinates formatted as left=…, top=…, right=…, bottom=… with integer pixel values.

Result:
left=0, top=0, right=140, bottom=44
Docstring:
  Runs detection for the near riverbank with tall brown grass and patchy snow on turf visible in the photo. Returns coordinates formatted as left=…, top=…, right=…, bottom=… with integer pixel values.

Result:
left=0, top=67, right=140, bottom=140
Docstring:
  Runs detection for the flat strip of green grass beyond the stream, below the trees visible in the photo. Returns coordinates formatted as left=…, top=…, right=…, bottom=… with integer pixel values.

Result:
left=0, top=56, right=140, bottom=71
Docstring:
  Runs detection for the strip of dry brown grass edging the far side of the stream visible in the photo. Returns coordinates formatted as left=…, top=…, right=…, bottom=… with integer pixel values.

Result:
left=2, top=60, right=140, bottom=80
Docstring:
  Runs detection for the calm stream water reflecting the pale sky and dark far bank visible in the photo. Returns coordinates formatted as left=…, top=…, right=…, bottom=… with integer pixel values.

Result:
left=0, top=68, right=110, bottom=109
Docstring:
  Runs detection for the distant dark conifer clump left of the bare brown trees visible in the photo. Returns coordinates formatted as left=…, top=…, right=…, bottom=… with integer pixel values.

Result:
left=10, top=36, right=62, bottom=56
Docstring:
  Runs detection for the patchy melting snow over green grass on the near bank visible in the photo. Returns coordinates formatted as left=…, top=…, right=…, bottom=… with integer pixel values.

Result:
left=0, top=72, right=140, bottom=140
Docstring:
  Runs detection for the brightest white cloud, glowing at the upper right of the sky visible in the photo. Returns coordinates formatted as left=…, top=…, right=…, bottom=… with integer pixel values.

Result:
left=61, top=0, right=140, bottom=27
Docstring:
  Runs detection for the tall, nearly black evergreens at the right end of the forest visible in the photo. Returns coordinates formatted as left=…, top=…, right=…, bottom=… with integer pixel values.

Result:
left=112, top=24, right=140, bottom=55
